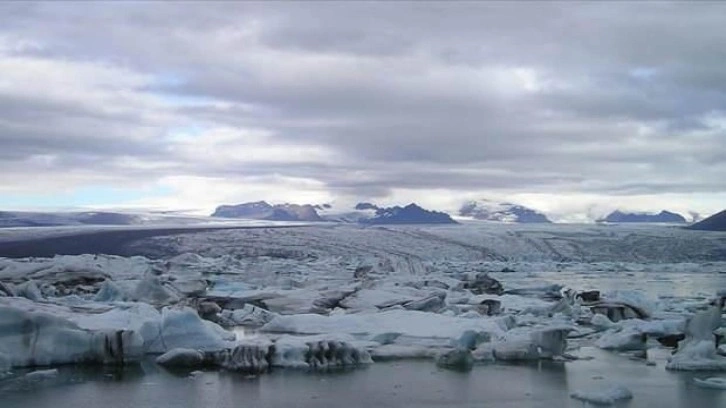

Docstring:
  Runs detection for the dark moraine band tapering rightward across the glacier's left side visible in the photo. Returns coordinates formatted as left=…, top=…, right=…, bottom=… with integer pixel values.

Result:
left=0, top=225, right=310, bottom=258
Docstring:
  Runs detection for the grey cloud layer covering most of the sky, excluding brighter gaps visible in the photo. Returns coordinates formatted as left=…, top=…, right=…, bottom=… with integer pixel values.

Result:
left=0, top=2, right=726, bottom=202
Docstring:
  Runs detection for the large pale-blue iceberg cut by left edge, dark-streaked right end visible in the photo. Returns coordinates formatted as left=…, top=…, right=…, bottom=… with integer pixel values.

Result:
left=0, top=306, right=143, bottom=367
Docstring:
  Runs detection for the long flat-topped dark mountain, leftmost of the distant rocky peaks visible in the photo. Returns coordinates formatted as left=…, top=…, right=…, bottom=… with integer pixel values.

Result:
left=212, top=201, right=323, bottom=221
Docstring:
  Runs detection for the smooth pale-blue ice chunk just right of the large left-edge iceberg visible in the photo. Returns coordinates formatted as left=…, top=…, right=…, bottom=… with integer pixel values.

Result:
left=141, top=307, right=230, bottom=353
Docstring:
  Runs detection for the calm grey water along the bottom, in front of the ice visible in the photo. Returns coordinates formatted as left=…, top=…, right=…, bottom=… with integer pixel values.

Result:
left=0, top=348, right=726, bottom=408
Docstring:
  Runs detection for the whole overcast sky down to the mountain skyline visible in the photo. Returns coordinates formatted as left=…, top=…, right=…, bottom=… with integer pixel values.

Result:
left=0, top=1, right=726, bottom=221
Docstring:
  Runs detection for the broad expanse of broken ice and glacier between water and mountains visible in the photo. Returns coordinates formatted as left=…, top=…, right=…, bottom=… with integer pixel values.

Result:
left=0, top=223, right=726, bottom=405
